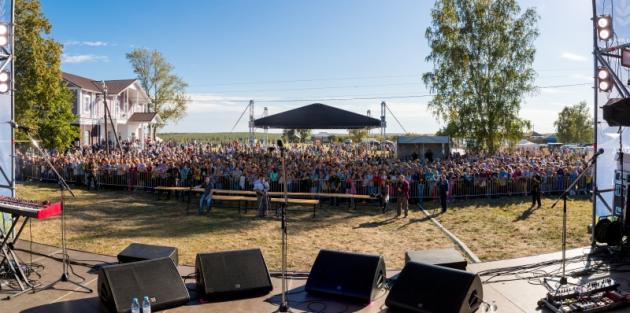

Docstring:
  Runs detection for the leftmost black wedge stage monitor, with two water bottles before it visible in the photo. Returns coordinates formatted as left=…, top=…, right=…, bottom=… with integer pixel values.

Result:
left=98, top=258, right=190, bottom=313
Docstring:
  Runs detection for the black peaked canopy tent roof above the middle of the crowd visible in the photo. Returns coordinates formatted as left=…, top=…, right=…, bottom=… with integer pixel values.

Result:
left=254, top=103, right=381, bottom=129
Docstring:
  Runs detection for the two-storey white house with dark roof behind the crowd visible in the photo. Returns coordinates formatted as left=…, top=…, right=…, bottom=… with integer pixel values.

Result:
left=62, top=72, right=162, bottom=145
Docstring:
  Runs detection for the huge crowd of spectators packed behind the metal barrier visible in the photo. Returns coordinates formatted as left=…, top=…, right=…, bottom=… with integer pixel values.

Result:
left=17, top=138, right=590, bottom=204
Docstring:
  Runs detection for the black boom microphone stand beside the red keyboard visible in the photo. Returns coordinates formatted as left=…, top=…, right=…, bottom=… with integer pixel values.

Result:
left=20, top=127, right=92, bottom=293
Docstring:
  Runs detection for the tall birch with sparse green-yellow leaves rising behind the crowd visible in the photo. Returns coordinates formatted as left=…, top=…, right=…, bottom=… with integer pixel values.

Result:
left=422, top=0, right=538, bottom=153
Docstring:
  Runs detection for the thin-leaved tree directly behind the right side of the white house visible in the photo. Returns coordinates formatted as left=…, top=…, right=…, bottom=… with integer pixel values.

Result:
left=127, top=49, right=188, bottom=139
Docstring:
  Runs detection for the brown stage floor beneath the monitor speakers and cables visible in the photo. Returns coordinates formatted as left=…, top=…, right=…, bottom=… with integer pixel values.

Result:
left=0, top=241, right=630, bottom=313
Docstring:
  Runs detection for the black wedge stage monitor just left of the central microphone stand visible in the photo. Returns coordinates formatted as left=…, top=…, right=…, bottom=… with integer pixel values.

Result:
left=195, top=249, right=273, bottom=299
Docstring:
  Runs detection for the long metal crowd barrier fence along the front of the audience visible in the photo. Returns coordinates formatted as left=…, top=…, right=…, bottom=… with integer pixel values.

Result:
left=16, top=165, right=592, bottom=200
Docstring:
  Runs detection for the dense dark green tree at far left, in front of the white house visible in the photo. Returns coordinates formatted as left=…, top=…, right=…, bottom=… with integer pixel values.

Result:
left=14, top=0, right=79, bottom=150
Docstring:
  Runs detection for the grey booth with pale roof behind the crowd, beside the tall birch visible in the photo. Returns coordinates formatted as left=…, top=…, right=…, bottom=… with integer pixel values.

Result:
left=396, top=136, right=450, bottom=160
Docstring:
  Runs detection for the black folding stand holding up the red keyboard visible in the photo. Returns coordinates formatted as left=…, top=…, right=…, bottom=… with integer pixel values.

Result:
left=0, top=216, right=35, bottom=300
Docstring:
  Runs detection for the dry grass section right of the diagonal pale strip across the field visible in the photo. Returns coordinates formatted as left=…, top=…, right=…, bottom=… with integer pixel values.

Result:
left=425, top=197, right=593, bottom=260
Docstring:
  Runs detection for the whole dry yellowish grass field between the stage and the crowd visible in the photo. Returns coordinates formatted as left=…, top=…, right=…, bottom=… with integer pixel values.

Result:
left=18, top=184, right=590, bottom=271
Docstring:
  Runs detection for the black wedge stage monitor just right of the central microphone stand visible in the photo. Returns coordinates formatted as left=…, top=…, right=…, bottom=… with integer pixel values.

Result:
left=305, top=250, right=386, bottom=303
